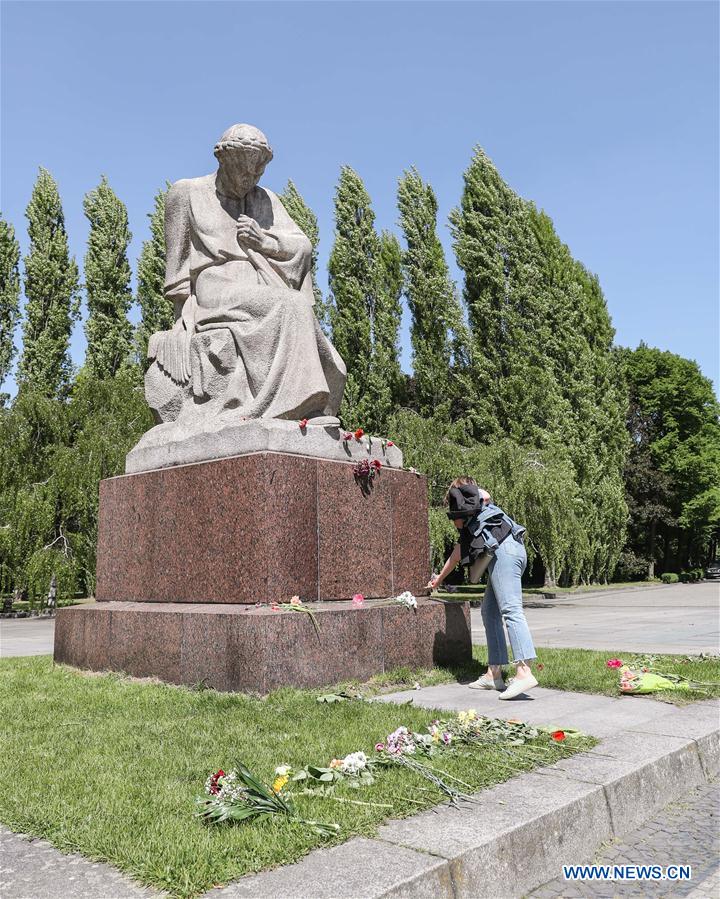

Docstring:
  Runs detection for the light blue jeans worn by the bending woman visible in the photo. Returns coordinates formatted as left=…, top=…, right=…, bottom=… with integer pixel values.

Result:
left=481, top=536, right=536, bottom=665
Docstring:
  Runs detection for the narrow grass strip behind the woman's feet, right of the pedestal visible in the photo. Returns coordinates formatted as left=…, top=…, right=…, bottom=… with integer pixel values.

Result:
left=368, top=646, right=720, bottom=704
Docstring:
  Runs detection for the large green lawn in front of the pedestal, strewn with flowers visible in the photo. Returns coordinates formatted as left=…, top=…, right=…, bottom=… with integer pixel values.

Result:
left=0, top=656, right=595, bottom=897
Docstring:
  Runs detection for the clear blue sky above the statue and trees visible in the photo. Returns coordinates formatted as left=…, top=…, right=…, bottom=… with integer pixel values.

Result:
left=0, top=0, right=718, bottom=387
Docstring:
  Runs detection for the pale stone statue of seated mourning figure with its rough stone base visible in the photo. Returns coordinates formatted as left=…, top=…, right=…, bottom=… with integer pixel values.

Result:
left=125, top=125, right=402, bottom=474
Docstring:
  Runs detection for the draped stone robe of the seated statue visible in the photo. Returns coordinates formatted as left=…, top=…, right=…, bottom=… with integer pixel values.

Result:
left=148, top=175, right=345, bottom=420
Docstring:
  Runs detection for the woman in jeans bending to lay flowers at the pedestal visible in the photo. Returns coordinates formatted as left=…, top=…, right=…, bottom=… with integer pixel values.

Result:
left=428, top=477, right=538, bottom=699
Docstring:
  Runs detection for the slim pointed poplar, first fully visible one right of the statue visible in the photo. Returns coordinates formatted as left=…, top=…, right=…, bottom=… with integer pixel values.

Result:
left=328, top=166, right=379, bottom=428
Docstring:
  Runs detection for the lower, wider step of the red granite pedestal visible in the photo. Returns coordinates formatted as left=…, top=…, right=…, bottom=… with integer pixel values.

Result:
left=55, top=599, right=472, bottom=693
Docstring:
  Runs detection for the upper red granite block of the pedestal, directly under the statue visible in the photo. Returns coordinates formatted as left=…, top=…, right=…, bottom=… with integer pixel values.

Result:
left=96, top=453, right=430, bottom=604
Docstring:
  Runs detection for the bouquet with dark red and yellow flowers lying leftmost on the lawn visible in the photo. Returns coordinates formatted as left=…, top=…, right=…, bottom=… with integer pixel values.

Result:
left=196, top=762, right=340, bottom=836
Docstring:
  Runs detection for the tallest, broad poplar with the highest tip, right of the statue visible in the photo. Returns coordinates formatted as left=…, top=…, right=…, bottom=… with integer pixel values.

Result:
left=450, top=148, right=567, bottom=448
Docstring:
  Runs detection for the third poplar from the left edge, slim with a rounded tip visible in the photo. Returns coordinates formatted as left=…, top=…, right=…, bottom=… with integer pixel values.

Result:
left=83, top=175, right=132, bottom=378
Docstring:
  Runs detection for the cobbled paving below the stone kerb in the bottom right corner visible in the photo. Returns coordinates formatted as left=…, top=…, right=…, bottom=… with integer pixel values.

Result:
left=528, top=781, right=720, bottom=899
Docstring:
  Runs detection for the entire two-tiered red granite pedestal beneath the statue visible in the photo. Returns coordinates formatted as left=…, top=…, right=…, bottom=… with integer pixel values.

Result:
left=55, top=452, right=471, bottom=692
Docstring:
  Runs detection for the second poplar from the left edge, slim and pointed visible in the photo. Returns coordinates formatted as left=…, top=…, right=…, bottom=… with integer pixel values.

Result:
left=18, top=168, right=80, bottom=396
